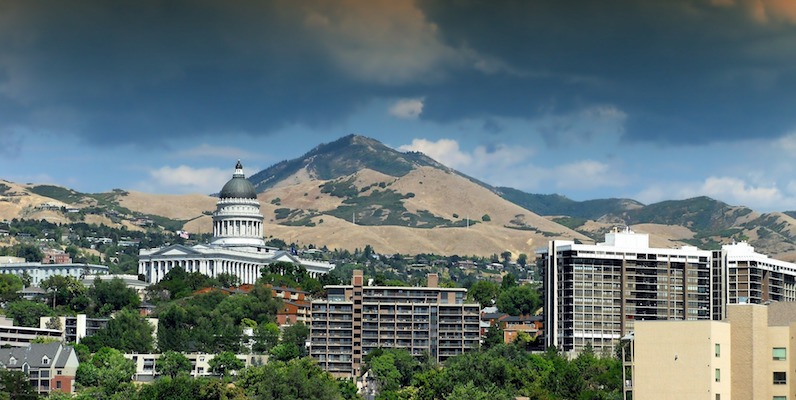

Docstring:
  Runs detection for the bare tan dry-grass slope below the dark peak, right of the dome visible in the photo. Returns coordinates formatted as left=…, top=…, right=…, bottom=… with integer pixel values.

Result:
left=252, top=167, right=589, bottom=256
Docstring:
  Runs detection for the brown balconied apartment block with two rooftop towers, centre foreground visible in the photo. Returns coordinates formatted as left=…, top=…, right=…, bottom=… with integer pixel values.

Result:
left=310, top=271, right=480, bottom=376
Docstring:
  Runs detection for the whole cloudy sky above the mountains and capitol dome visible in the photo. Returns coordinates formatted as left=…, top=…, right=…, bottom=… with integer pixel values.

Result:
left=0, top=0, right=796, bottom=212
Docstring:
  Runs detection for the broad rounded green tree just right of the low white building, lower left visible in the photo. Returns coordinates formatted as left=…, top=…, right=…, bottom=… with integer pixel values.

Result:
left=82, top=309, right=154, bottom=353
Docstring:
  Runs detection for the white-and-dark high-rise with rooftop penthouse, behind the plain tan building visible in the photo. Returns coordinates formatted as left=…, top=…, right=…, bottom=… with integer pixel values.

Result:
left=537, top=229, right=712, bottom=353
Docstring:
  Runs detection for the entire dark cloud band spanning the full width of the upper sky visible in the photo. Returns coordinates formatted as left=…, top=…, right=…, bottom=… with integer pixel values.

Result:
left=0, top=0, right=796, bottom=148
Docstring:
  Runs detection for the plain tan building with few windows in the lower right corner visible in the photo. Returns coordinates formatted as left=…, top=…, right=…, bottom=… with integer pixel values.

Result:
left=625, top=303, right=796, bottom=400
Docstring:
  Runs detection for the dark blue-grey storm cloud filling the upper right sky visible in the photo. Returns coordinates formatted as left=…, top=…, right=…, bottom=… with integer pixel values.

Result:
left=420, top=0, right=796, bottom=143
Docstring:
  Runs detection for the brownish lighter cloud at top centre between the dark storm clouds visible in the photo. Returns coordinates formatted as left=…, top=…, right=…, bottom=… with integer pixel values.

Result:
left=304, top=0, right=464, bottom=85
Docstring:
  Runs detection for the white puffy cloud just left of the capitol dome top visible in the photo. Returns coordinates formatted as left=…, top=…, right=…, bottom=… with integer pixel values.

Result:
left=139, top=165, right=232, bottom=194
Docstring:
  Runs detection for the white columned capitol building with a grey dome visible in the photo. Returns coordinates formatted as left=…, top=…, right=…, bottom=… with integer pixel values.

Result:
left=138, top=161, right=334, bottom=284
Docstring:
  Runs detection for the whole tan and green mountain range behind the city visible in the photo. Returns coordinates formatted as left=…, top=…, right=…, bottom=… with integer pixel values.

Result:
left=0, top=135, right=796, bottom=260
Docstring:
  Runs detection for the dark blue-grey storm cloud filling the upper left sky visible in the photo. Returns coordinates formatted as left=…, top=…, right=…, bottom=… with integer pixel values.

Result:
left=0, top=1, right=378, bottom=147
